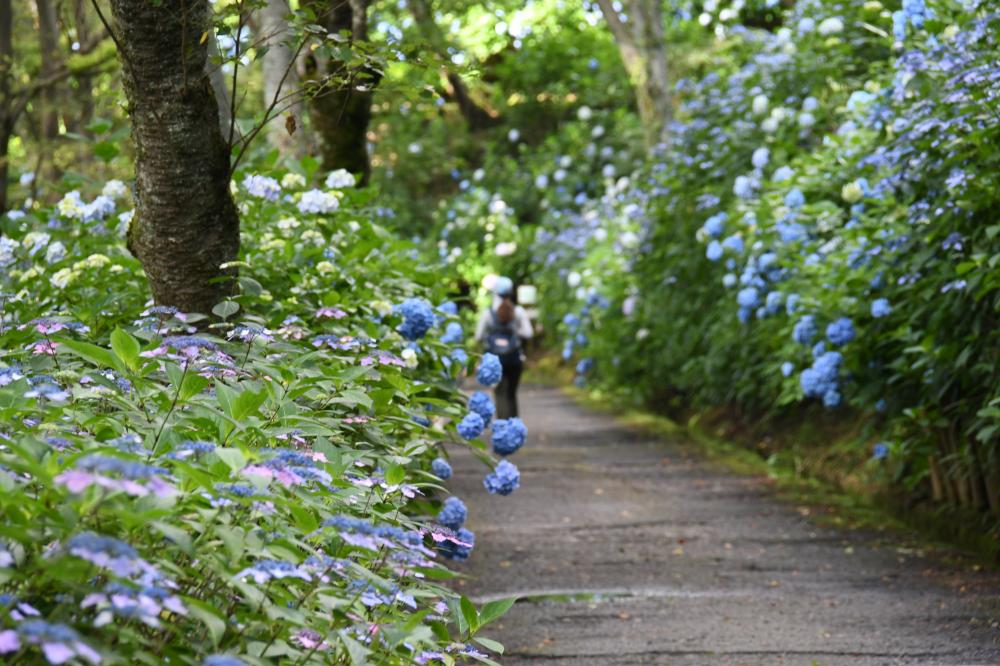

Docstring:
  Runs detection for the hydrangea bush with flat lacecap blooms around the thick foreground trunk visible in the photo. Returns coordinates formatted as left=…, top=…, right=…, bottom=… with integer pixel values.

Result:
left=0, top=165, right=511, bottom=665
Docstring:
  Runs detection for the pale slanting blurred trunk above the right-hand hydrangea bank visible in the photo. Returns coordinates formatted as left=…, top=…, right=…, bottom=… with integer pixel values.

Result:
left=597, top=0, right=673, bottom=148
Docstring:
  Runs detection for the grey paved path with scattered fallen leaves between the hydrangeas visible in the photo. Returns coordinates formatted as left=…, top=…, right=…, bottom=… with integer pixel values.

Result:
left=451, top=387, right=1000, bottom=666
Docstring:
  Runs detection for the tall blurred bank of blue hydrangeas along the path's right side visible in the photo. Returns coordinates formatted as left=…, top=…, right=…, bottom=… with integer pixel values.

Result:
left=428, top=0, right=1000, bottom=512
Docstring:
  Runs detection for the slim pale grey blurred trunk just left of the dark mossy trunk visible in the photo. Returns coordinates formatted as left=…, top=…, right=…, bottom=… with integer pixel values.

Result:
left=260, top=0, right=305, bottom=159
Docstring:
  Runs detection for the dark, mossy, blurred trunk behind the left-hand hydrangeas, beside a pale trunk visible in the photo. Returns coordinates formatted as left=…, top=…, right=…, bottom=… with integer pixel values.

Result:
left=306, top=0, right=382, bottom=185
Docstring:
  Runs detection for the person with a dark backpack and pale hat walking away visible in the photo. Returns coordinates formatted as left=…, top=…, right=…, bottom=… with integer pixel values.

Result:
left=476, top=277, right=534, bottom=419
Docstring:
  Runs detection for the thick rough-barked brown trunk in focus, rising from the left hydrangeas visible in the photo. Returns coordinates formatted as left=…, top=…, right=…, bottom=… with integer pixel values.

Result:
left=111, top=0, right=240, bottom=313
